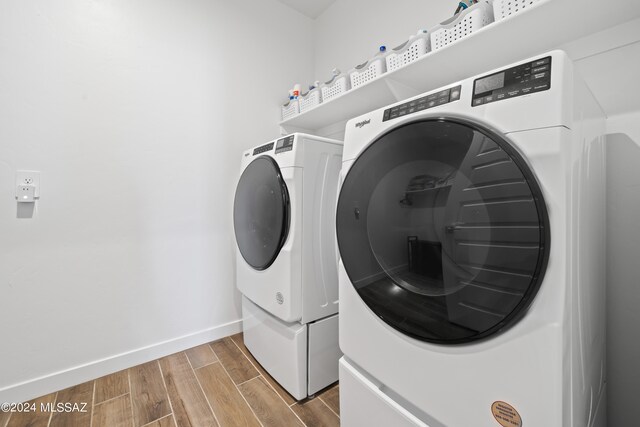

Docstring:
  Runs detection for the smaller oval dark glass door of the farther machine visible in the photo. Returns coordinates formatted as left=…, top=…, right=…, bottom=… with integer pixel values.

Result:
left=233, top=156, right=291, bottom=270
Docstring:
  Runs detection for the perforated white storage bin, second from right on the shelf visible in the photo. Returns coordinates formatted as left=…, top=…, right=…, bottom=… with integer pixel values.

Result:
left=431, top=1, right=493, bottom=50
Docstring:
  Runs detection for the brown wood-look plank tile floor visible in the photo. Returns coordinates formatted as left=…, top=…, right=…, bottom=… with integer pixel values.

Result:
left=0, top=334, right=340, bottom=427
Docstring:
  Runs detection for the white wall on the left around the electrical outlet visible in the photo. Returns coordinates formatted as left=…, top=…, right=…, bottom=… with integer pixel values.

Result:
left=0, top=0, right=313, bottom=401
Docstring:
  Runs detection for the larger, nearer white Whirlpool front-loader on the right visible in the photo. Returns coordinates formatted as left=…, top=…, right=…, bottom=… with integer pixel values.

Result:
left=336, top=51, right=606, bottom=427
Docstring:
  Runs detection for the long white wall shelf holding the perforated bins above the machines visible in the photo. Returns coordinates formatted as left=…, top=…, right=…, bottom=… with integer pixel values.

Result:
left=280, top=0, right=640, bottom=134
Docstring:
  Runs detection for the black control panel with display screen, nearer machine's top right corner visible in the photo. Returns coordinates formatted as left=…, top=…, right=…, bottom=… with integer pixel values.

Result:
left=471, top=56, right=551, bottom=107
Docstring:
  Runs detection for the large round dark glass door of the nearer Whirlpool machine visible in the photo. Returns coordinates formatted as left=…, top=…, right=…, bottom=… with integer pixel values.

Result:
left=337, top=119, right=549, bottom=344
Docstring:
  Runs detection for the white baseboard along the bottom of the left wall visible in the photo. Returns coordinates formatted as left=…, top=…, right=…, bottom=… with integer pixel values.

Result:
left=0, top=319, right=242, bottom=403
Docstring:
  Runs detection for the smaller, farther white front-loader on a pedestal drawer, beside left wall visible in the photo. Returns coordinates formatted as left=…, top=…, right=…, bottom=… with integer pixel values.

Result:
left=233, top=133, right=342, bottom=399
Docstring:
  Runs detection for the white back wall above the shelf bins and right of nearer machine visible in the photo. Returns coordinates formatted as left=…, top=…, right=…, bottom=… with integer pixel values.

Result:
left=315, top=0, right=640, bottom=426
